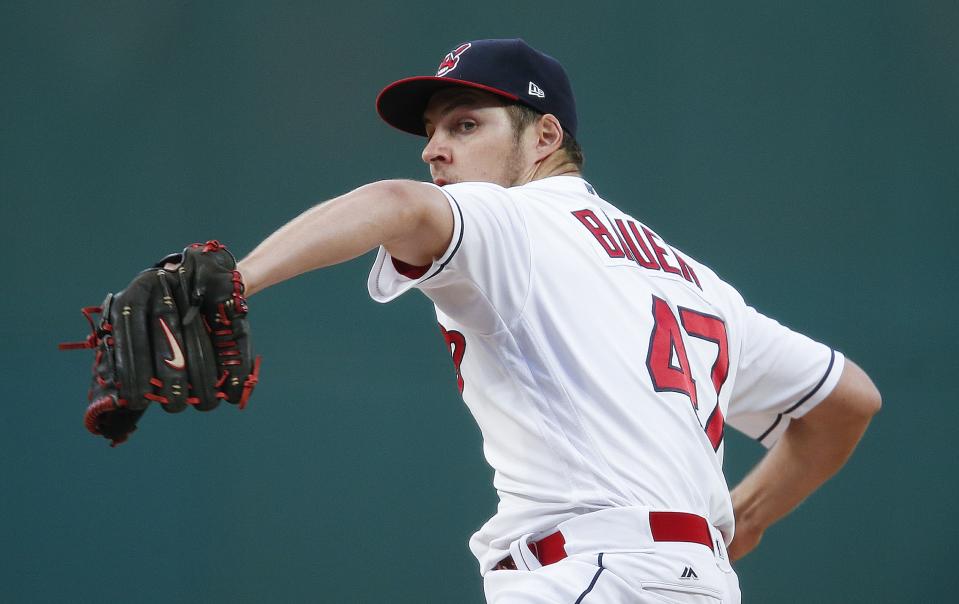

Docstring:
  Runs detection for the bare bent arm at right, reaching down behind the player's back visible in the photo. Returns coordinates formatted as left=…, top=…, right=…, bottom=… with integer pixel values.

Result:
left=729, top=359, right=882, bottom=560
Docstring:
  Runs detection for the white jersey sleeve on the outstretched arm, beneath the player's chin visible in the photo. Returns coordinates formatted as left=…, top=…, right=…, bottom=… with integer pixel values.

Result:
left=367, top=183, right=530, bottom=331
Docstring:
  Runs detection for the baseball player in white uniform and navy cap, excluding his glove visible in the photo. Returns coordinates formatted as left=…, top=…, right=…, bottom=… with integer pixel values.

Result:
left=238, top=40, right=880, bottom=604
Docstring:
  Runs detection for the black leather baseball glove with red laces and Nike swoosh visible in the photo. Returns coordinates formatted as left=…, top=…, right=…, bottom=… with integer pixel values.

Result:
left=60, top=241, right=260, bottom=447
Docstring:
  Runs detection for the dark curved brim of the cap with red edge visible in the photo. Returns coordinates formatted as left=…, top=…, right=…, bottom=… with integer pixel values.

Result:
left=376, top=76, right=519, bottom=136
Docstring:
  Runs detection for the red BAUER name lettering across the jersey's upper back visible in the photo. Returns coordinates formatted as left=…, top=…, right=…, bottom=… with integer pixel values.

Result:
left=572, top=208, right=703, bottom=289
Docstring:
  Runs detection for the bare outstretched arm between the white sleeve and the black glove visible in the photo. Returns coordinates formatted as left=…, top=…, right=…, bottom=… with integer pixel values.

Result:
left=237, top=180, right=453, bottom=296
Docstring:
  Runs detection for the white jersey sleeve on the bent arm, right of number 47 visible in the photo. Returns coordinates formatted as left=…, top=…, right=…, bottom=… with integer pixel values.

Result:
left=727, top=306, right=845, bottom=447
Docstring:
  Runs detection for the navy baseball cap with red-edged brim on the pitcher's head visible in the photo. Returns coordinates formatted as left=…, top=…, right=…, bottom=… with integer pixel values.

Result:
left=376, top=38, right=576, bottom=136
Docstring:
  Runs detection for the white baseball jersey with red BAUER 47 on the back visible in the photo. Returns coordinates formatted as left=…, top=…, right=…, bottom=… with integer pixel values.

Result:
left=369, top=176, right=843, bottom=574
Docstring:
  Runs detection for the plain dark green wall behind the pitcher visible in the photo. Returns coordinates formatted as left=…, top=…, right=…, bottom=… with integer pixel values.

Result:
left=0, top=0, right=959, bottom=602
